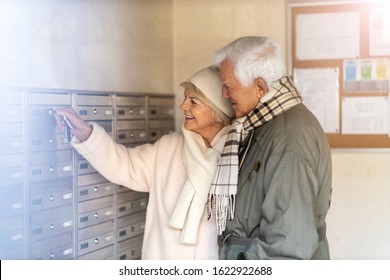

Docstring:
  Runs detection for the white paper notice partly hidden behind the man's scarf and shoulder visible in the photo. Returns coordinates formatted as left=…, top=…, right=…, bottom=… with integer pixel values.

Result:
left=294, top=68, right=340, bottom=133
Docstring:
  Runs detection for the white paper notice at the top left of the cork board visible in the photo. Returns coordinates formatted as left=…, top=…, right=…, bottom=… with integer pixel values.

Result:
left=296, top=12, right=360, bottom=60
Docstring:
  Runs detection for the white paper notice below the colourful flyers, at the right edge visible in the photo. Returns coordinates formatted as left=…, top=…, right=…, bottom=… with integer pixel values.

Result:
left=342, top=96, right=389, bottom=134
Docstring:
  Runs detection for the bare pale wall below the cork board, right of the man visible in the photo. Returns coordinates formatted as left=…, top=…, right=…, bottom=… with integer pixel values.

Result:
left=328, top=150, right=390, bottom=260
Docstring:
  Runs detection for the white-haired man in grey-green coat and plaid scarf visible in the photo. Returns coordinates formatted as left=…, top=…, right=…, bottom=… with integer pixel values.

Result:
left=208, top=37, right=332, bottom=259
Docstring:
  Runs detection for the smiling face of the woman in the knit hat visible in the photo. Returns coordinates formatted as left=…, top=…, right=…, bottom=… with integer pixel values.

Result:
left=180, top=89, right=223, bottom=143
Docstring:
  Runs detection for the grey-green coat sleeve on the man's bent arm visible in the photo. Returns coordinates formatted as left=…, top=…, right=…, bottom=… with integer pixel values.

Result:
left=245, top=152, right=319, bottom=259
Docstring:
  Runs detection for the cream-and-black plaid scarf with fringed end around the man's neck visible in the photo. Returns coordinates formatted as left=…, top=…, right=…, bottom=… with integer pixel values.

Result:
left=207, top=77, right=302, bottom=235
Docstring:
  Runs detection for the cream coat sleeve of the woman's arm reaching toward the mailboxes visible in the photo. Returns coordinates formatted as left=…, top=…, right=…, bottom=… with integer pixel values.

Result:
left=72, top=123, right=158, bottom=192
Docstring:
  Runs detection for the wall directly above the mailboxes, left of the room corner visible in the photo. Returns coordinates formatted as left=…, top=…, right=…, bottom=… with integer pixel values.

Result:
left=0, top=0, right=173, bottom=93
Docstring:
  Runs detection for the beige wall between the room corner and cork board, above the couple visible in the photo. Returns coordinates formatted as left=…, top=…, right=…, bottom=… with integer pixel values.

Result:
left=173, top=0, right=286, bottom=128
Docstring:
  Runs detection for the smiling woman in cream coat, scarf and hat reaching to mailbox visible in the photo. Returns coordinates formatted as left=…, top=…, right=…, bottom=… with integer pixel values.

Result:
left=56, top=67, right=234, bottom=259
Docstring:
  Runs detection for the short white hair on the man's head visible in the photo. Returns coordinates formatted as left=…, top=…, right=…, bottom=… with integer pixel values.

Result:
left=214, top=36, right=286, bottom=88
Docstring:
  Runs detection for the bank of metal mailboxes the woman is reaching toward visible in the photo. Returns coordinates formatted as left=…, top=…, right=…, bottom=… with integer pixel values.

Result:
left=0, top=89, right=174, bottom=260
